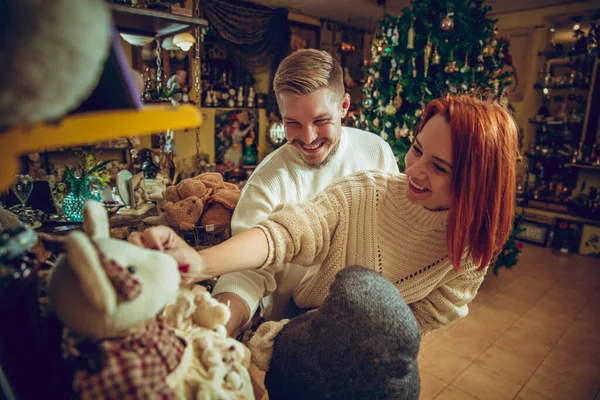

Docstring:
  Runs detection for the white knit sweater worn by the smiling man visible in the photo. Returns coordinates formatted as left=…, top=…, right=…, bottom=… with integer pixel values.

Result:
left=213, top=127, right=398, bottom=319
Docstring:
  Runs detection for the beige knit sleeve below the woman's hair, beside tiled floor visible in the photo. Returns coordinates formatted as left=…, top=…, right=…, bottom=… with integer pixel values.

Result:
left=410, top=262, right=487, bottom=335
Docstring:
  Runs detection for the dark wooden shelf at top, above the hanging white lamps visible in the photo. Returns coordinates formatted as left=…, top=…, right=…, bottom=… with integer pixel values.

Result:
left=108, top=3, right=208, bottom=37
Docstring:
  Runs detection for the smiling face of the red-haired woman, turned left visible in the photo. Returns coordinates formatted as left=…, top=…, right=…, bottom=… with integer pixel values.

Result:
left=404, top=115, right=452, bottom=210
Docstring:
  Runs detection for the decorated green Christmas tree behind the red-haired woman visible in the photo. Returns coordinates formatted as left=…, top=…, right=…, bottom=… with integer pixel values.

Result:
left=356, top=0, right=513, bottom=170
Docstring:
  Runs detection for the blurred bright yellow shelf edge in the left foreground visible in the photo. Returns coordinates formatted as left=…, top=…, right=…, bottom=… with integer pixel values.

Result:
left=0, top=104, right=202, bottom=191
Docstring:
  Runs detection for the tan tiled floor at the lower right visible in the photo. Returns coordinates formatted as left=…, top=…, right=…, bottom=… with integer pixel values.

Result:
left=419, top=245, right=600, bottom=400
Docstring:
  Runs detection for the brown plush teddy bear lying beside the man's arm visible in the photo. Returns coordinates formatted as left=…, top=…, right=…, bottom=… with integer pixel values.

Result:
left=144, top=172, right=241, bottom=233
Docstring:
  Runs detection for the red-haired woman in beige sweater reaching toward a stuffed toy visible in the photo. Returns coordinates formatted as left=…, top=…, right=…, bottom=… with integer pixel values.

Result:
left=132, top=96, right=518, bottom=334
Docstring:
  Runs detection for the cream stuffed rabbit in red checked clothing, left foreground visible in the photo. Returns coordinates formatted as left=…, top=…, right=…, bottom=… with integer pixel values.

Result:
left=48, top=202, right=191, bottom=399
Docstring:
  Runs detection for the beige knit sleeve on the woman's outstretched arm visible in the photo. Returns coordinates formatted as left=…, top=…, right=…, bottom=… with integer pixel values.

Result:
left=258, top=184, right=348, bottom=273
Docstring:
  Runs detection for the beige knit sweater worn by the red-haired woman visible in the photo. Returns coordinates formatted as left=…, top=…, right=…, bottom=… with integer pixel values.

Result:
left=259, top=171, right=485, bottom=334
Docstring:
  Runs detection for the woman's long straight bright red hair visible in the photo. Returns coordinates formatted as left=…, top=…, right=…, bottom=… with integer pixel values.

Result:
left=415, top=95, right=519, bottom=270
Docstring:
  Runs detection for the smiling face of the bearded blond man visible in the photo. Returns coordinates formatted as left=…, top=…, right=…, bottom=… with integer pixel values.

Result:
left=277, top=88, right=350, bottom=167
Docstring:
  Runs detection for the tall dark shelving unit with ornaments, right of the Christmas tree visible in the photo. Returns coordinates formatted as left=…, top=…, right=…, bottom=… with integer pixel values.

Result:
left=524, top=34, right=600, bottom=214
